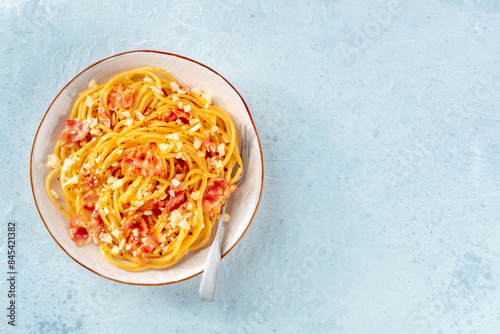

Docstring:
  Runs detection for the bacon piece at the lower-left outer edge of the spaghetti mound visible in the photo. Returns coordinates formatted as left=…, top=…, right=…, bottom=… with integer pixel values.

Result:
left=68, top=210, right=104, bottom=247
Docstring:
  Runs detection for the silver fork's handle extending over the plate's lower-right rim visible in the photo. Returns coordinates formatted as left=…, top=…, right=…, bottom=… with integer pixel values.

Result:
left=198, top=204, right=226, bottom=302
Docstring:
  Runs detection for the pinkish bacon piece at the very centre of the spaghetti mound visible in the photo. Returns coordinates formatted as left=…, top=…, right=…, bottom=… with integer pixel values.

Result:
left=121, top=143, right=165, bottom=177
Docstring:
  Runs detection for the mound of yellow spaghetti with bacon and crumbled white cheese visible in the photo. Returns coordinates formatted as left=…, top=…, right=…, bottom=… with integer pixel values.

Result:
left=46, top=67, right=242, bottom=271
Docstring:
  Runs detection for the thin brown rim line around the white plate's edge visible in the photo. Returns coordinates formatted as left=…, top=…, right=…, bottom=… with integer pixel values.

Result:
left=30, top=50, right=264, bottom=286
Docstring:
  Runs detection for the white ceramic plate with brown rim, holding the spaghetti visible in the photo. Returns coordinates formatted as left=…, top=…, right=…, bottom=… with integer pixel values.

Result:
left=30, top=50, right=264, bottom=285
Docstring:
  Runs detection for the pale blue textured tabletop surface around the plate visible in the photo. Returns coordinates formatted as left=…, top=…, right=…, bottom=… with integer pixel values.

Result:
left=0, top=0, right=500, bottom=333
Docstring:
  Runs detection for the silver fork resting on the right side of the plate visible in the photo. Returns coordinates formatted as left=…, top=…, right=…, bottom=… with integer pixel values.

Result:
left=198, top=125, right=250, bottom=302
